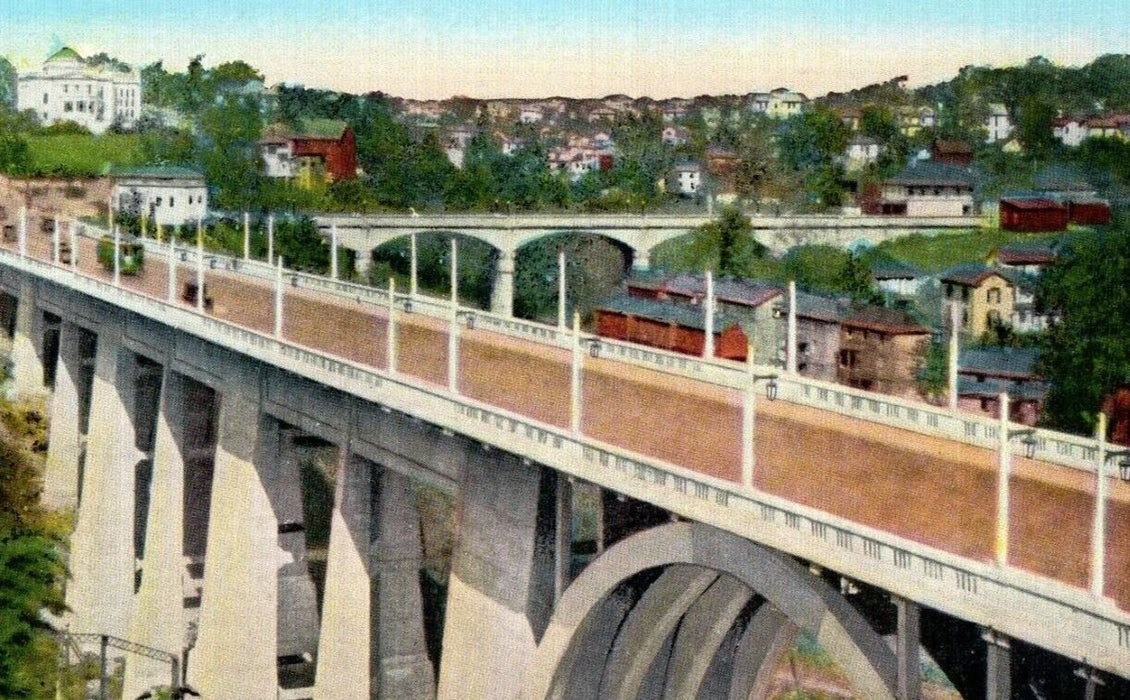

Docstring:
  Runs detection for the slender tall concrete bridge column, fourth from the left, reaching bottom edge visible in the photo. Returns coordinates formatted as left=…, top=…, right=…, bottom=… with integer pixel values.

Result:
left=122, top=366, right=191, bottom=698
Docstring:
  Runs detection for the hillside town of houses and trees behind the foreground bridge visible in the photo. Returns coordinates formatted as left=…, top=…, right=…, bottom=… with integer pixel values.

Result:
left=0, top=47, right=1130, bottom=441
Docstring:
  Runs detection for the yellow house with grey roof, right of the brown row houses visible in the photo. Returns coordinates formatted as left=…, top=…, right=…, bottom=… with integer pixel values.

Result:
left=940, top=262, right=1016, bottom=337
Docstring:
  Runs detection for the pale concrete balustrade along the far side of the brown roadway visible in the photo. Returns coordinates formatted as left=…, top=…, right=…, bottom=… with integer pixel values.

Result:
left=61, top=224, right=1098, bottom=472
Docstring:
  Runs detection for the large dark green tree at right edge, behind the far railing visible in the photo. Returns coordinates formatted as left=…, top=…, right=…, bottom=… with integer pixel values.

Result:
left=1037, top=223, right=1130, bottom=433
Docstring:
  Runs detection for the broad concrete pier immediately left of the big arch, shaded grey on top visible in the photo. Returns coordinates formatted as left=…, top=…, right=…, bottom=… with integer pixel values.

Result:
left=440, top=452, right=565, bottom=698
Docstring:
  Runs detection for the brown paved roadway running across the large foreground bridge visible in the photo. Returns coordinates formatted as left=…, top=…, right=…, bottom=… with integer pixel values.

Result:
left=2, top=221, right=1130, bottom=611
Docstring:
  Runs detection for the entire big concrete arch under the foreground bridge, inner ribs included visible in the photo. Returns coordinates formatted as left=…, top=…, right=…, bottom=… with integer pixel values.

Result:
left=527, top=522, right=896, bottom=700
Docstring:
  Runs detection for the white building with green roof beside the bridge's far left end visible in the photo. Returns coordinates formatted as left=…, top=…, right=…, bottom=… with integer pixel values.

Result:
left=111, top=166, right=208, bottom=226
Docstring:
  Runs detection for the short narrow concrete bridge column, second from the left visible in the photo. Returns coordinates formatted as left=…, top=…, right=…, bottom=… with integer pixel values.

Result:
left=43, top=321, right=84, bottom=508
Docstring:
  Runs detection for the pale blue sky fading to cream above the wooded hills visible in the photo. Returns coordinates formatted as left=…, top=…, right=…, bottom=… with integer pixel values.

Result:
left=0, top=0, right=1130, bottom=98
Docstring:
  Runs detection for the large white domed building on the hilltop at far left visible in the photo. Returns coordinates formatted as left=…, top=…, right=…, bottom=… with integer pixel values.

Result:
left=16, top=46, right=141, bottom=133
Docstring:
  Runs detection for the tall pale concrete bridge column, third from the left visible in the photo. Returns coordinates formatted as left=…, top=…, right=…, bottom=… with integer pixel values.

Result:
left=67, top=326, right=142, bottom=638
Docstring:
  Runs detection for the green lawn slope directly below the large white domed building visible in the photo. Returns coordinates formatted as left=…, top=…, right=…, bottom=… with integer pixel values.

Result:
left=27, top=133, right=142, bottom=175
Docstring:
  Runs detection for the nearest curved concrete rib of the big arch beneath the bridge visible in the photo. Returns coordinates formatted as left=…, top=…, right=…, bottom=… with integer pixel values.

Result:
left=527, top=522, right=896, bottom=700
